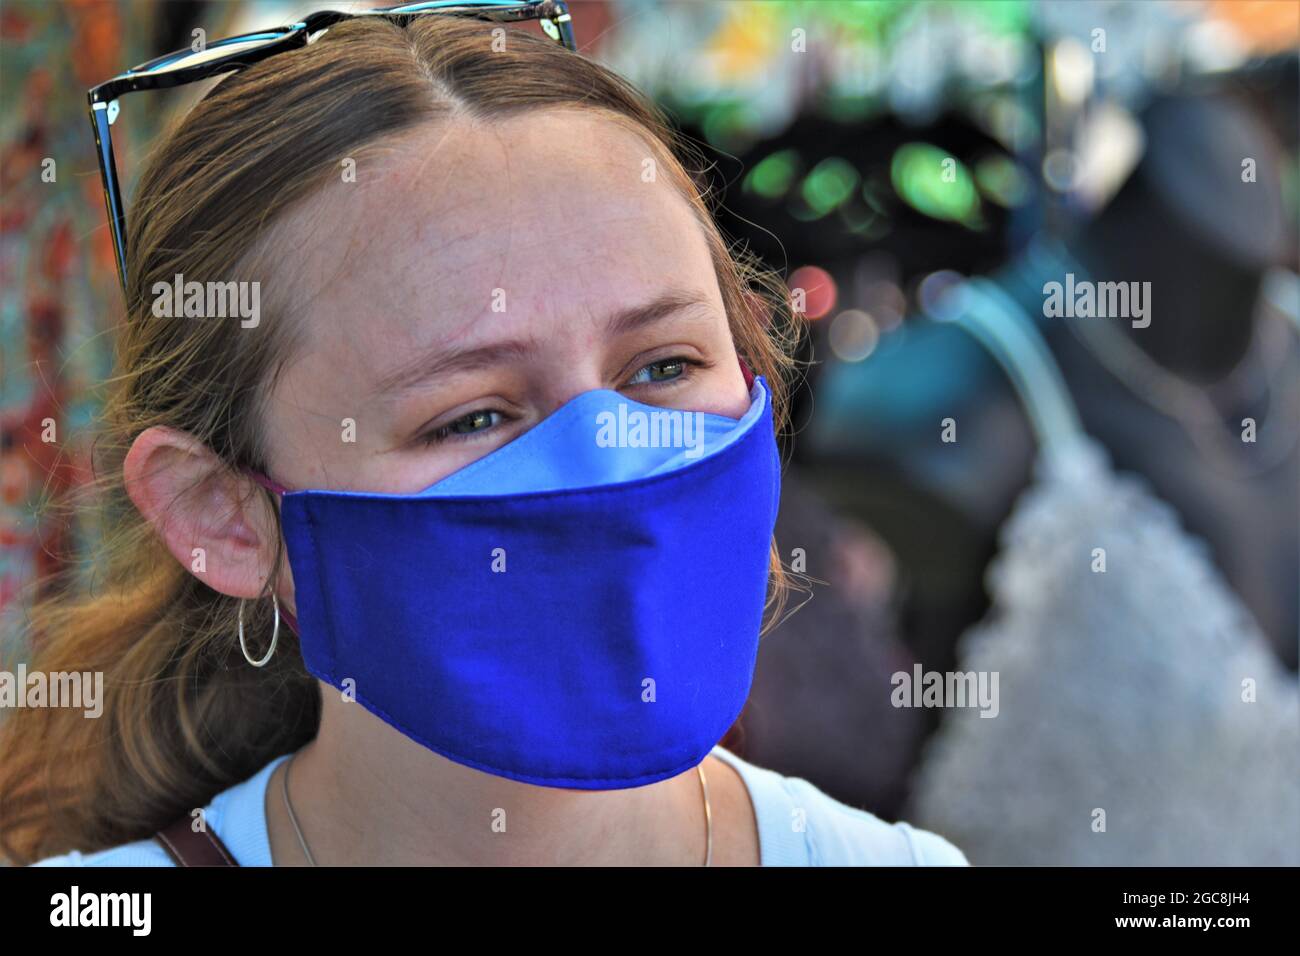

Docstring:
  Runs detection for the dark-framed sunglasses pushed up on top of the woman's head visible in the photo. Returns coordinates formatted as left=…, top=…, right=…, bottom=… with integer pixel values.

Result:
left=88, top=0, right=577, bottom=295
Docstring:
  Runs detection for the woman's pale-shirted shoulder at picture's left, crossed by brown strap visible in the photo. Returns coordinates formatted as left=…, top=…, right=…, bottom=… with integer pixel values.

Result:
left=31, top=754, right=289, bottom=866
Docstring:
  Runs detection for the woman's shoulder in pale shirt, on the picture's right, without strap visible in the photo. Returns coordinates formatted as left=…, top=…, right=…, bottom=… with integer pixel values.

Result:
left=714, top=747, right=970, bottom=866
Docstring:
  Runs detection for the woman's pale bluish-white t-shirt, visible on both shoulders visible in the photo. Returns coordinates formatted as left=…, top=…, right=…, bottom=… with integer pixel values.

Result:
left=33, top=747, right=970, bottom=866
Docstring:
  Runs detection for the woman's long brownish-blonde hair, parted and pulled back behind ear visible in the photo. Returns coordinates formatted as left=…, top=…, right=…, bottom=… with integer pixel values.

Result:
left=0, top=17, right=797, bottom=864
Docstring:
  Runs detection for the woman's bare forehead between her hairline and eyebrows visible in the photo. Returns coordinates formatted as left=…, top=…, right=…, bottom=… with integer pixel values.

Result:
left=258, top=109, right=720, bottom=345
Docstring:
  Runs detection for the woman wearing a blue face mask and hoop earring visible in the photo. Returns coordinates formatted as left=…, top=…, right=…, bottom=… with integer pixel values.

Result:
left=0, top=7, right=966, bottom=866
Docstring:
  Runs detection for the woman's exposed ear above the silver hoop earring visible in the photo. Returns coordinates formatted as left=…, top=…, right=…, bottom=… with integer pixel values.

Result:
left=122, top=425, right=293, bottom=601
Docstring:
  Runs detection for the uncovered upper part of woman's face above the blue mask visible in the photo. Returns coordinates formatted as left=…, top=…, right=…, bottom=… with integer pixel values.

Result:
left=264, top=111, right=749, bottom=493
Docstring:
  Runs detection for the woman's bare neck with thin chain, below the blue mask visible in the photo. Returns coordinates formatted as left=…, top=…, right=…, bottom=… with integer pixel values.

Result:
left=267, top=692, right=705, bottom=866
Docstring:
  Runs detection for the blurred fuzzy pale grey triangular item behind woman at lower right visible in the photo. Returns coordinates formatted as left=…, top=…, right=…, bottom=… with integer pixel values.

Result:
left=907, top=438, right=1300, bottom=866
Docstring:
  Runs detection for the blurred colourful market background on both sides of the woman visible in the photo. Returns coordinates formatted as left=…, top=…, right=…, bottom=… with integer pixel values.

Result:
left=0, top=0, right=1300, bottom=865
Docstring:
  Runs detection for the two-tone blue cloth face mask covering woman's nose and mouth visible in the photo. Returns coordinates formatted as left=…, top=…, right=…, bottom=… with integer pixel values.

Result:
left=250, top=369, right=780, bottom=790
